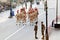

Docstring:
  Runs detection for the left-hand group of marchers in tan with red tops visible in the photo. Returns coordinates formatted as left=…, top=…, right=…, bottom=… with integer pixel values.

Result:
left=16, top=8, right=26, bottom=25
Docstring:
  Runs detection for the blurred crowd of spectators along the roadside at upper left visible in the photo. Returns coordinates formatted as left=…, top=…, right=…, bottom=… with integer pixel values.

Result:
left=0, top=2, right=17, bottom=12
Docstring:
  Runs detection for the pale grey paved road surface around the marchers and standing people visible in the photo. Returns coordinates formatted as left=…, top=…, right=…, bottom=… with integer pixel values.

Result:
left=0, top=1, right=60, bottom=40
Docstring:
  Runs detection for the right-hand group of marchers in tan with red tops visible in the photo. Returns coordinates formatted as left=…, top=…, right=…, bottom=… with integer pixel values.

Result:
left=28, top=7, right=38, bottom=23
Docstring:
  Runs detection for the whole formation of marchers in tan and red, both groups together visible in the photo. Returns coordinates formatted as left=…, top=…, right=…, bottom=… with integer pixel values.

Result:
left=16, top=7, right=38, bottom=25
